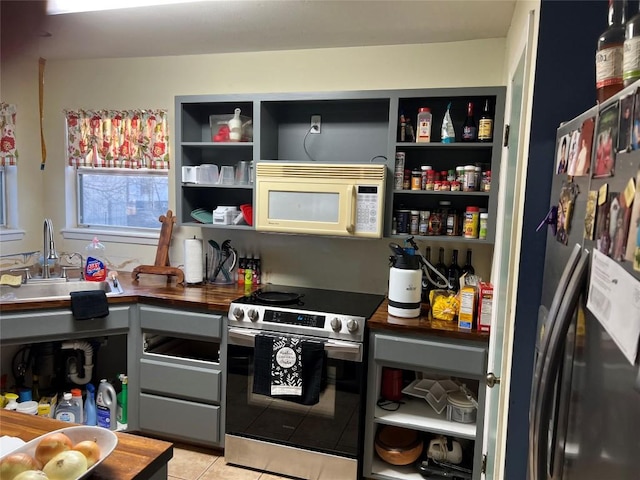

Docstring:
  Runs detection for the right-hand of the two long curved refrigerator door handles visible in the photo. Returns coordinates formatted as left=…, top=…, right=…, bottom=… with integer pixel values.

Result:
left=530, top=252, right=589, bottom=480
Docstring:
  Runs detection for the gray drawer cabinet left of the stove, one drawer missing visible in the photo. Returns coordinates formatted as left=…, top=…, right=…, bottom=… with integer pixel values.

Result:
left=138, top=304, right=226, bottom=447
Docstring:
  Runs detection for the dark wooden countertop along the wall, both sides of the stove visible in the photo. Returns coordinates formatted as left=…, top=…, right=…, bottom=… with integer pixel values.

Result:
left=0, top=272, right=489, bottom=342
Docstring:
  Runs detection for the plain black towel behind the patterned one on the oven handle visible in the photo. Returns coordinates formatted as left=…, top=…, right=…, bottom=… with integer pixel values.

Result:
left=253, top=334, right=327, bottom=405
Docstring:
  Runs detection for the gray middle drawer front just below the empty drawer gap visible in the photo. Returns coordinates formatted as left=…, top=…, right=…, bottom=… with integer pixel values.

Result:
left=140, top=358, right=222, bottom=403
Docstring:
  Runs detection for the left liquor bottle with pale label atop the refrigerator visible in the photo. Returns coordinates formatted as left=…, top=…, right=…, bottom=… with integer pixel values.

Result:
left=596, top=0, right=627, bottom=103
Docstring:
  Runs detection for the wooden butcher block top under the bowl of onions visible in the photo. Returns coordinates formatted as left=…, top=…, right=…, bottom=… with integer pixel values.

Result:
left=0, top=410, right=173, bottom=480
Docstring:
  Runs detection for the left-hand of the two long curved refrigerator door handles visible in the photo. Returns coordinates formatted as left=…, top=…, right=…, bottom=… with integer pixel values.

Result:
left=528, top=244, right=582, bottom=480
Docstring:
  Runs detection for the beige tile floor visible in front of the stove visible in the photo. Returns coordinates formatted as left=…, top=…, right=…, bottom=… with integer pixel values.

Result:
left=169, top=443, right=288, bottom=480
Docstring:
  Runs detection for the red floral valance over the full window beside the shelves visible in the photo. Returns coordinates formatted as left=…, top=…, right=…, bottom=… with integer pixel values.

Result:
left=65, top=110, right=169, bottom=169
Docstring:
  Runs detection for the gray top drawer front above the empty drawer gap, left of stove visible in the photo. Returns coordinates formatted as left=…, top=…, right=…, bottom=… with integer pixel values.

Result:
left=140, top=305, right=222, bottom=338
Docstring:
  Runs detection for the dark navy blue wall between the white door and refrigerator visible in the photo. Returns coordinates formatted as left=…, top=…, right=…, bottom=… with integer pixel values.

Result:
left=504, top=0, right=608, bottom=480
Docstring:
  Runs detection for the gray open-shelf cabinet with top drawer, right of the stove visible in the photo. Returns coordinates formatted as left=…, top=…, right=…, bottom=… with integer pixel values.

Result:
left=363, top=331, right=487, bottom=480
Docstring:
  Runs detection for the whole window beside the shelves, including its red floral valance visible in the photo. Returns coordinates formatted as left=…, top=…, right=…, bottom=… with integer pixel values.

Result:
left=65, top=110, right=169, bottom=234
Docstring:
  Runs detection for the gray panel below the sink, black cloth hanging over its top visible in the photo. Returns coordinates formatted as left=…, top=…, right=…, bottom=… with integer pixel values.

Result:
left=1, top=305, right=131, bottom=343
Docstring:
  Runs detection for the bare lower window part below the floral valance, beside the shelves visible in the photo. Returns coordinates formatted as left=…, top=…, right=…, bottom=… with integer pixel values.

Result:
left=77, top=168, right=169, bottom=228
